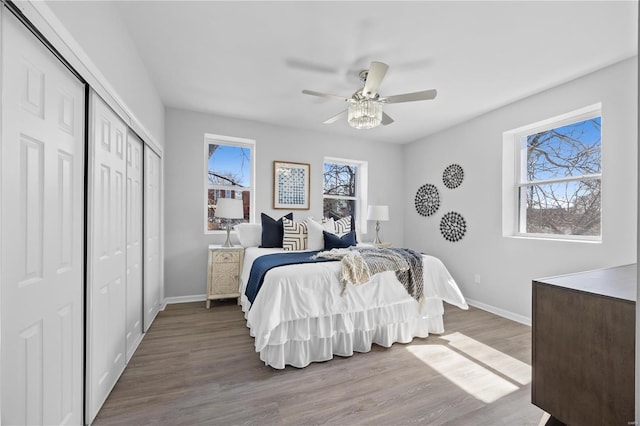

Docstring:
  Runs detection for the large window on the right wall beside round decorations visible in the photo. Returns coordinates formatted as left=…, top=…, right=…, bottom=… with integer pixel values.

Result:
left=504, top=105, right=602, bottom=240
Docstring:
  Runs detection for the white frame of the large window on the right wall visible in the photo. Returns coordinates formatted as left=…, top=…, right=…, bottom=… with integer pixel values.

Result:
left=502, top=103, right=604, bottom=243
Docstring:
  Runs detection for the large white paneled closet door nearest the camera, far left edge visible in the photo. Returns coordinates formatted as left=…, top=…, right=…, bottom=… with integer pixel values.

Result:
left=0, top=10, right=85, bottom=425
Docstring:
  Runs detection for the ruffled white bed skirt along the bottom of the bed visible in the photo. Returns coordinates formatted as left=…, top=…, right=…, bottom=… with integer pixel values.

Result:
left=243, top=298, right=444, bottom=369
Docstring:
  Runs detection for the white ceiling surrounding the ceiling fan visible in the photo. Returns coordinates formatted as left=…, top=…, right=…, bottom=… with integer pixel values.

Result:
left=117, top=1, right=638, bottom=143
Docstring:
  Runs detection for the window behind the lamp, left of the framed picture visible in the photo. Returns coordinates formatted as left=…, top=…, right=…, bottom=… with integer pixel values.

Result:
left=204, top=134, right=255, bottom=233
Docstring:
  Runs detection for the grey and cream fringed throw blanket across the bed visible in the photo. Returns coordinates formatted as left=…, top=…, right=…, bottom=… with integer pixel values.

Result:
left=317, top=247, right=424, bottom=303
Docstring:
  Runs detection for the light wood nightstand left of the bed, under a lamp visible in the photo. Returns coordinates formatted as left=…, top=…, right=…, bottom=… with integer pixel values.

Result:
left=207, top=245, right=244, bottom=309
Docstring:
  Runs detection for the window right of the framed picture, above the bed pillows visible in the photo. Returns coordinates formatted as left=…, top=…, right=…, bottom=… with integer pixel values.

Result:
left=322, top=158, right=367, bottom=232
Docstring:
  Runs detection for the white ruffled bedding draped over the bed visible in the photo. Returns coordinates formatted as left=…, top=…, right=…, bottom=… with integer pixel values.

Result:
left=240, top=247, right=468, bottom=368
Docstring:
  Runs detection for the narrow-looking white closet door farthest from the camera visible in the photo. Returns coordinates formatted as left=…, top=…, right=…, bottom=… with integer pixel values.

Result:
left=144, top=148, right=163, bottom=332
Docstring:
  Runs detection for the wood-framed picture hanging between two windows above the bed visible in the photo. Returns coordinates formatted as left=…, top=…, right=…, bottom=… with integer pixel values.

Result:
left=273, top=161, right=311, bottom=210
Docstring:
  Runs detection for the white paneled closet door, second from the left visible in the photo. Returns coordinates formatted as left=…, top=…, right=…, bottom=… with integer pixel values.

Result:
left=87, top=92, right=127, bottom=422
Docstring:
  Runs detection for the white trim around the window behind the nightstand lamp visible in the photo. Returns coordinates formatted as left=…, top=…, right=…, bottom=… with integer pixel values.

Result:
left=202, top=133, right=256, bottom=235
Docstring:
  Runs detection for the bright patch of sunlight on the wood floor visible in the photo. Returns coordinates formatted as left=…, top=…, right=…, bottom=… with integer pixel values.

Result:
left=407, top=333, right=531, bottom=403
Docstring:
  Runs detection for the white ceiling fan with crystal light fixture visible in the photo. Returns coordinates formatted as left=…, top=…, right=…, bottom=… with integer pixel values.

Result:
left=302, top=61, right=438, bottom=129
